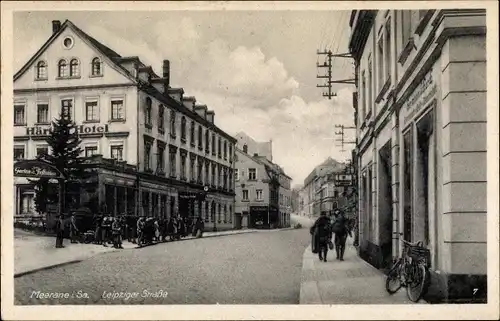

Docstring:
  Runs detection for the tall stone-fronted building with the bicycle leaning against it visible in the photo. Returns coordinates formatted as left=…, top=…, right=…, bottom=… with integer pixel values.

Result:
left=349, top=9, right=487, bottom=301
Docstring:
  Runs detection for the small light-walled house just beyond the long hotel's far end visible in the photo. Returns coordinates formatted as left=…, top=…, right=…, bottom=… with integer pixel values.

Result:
left=234, top=133, right=292, bottom=228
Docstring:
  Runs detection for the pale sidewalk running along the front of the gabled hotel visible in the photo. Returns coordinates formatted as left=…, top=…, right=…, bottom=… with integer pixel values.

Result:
left=14, top=228, right=288, bottom=277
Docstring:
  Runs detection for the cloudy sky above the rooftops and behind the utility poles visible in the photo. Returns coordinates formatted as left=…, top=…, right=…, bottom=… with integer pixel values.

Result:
left=13, top=11, right=354, bottom=184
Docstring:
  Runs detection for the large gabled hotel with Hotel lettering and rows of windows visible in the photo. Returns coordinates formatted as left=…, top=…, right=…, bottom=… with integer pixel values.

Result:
left=14, top=20, right=236, bottom=228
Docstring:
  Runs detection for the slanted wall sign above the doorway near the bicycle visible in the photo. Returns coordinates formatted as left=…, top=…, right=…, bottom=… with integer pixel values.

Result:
left=402, top=70, right=437, bottom=127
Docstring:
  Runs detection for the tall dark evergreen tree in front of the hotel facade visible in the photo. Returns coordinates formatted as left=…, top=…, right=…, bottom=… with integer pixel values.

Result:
left=35, top=113, right=85, bottom=211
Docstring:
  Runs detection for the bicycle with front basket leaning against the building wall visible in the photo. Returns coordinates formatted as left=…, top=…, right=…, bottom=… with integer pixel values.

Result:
left=385, top=236, right=430, bottom=302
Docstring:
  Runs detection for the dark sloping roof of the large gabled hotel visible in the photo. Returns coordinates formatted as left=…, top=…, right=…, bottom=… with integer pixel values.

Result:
left=14, top=20, right=237, bottom=143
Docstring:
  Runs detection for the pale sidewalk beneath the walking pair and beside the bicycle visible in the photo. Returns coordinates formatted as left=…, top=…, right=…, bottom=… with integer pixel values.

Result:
left=300, top=238, right=425, bottom=304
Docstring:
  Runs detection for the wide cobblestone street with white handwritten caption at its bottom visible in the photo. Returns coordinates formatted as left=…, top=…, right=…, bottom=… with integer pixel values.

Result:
left=15, top=229, right=309, bottom=304
